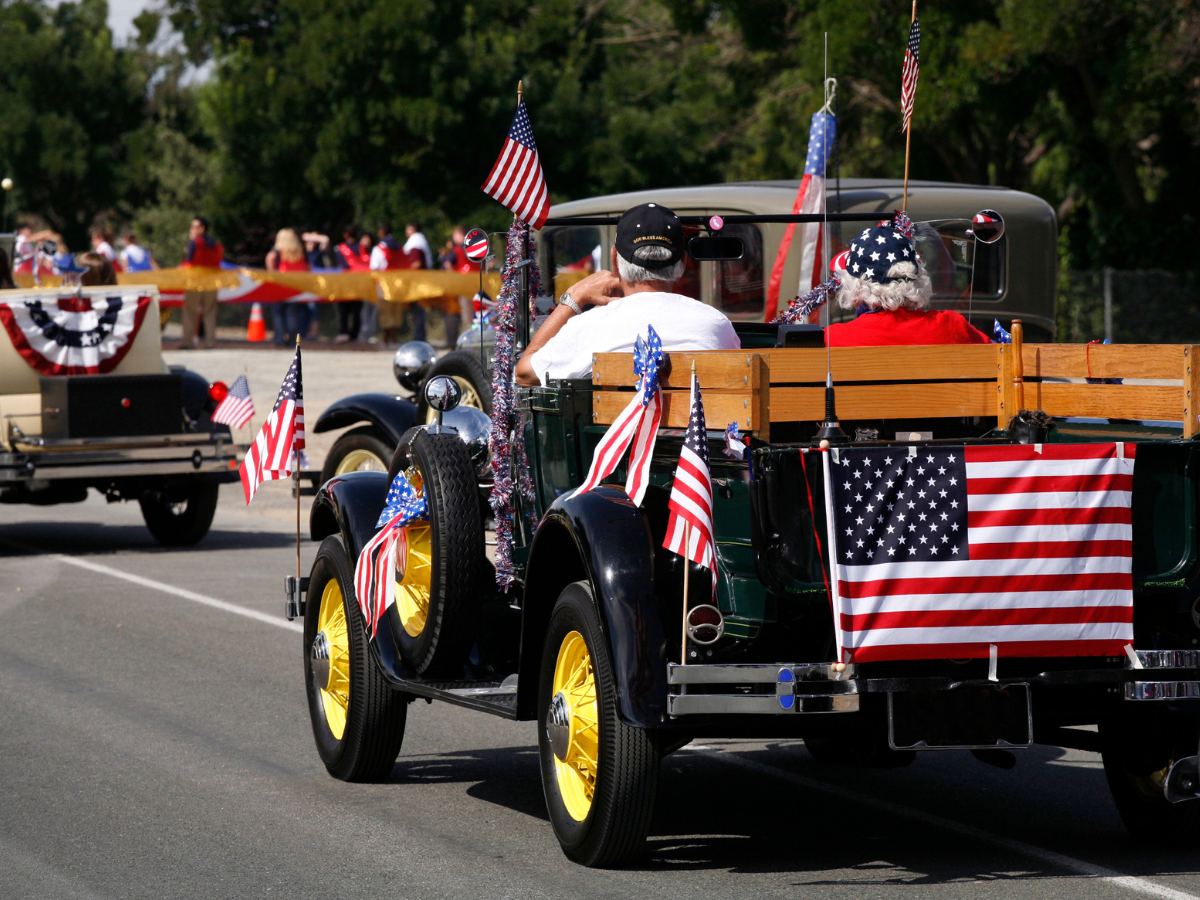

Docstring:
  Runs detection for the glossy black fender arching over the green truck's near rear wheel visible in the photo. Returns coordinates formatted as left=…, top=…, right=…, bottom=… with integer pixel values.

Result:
left=517, top=487, right=667, bottom=728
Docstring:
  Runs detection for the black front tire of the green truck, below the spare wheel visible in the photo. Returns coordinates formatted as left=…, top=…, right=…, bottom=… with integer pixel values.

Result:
left=304, top=534, right=408, bottom=781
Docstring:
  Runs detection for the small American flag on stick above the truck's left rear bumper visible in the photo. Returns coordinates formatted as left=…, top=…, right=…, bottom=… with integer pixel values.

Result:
left=662, top=372, right=716, bottom=593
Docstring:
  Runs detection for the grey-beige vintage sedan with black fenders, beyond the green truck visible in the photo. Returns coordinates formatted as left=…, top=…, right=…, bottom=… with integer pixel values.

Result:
left=306, top=178, right=1058, bottom=480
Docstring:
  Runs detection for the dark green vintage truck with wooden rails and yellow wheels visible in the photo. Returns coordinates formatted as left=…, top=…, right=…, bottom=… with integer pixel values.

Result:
left=288, top=211, right=1200, bottom=865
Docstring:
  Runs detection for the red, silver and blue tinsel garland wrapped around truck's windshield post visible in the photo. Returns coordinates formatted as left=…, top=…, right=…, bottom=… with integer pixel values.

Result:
left=487, top=220, right=541, bottom=590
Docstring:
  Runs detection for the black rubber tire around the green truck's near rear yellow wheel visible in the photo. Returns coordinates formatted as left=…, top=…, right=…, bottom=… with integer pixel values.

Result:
left=538, top=582, right=659, bottom=868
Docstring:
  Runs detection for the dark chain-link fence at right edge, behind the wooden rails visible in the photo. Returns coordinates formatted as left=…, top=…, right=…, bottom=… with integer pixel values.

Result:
left=1057, top=269, right=1200, bottom=343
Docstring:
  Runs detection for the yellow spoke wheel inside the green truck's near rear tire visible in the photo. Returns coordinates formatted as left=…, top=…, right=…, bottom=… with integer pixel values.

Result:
left=551, top=631, right=600, bottom=822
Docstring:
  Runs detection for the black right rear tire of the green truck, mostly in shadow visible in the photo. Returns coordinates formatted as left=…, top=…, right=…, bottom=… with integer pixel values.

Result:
left=1100, top=702, right=1200, bottom=847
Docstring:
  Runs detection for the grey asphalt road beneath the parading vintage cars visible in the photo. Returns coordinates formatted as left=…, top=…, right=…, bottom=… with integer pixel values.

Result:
left=0, top=494, right=1200, bottom=900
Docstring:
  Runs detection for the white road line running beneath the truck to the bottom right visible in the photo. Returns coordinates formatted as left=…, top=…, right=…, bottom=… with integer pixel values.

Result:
left=696, top=748, right=1200, bottom=900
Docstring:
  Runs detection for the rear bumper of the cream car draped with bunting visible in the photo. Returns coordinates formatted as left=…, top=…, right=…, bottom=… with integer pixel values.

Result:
left=0, top=434, right=238, bottom=487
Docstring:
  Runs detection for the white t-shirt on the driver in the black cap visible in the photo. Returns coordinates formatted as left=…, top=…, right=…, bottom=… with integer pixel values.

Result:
left=529, top=290, right=742, bottom=384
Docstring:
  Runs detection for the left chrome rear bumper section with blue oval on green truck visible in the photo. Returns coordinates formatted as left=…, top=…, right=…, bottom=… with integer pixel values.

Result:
left=667, top=662, right=858, bottom=716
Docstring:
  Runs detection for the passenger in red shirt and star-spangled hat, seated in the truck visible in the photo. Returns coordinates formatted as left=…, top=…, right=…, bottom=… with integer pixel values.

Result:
left=826, top=216, right=990, bottom=347
